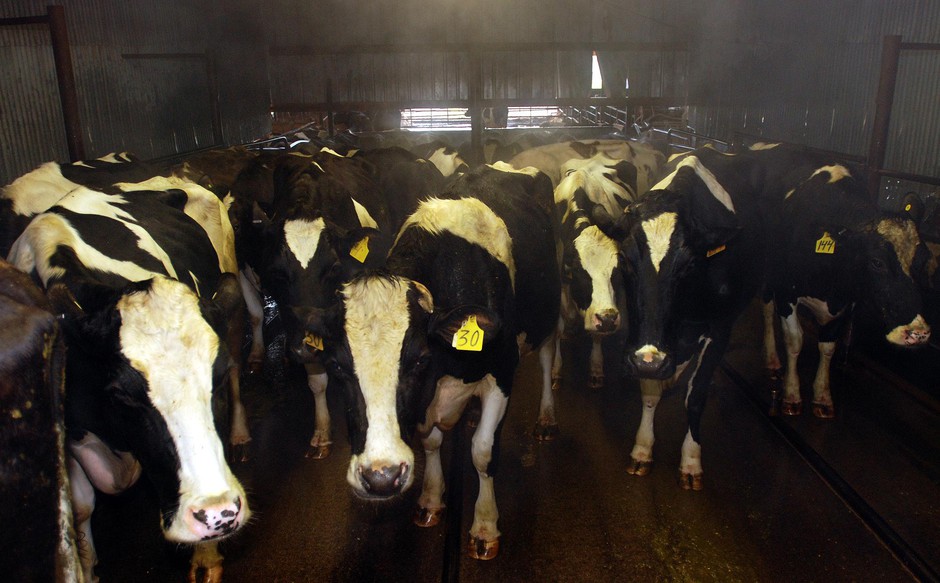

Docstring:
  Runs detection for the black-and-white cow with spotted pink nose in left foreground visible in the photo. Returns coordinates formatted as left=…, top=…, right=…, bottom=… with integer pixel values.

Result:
left=10, top=187, right=251, bottom=581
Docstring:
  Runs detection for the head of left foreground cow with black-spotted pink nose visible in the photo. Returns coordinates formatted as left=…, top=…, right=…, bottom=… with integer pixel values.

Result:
left=49, top=275, right=251, bottom=543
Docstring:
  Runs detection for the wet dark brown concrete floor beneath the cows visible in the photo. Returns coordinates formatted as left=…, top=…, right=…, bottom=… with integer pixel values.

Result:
left=86, top=302, right=940, bottom=583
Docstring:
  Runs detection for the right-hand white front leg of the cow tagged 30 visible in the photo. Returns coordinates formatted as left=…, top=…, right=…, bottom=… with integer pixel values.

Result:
left=469, top=380, right=509, bottom=561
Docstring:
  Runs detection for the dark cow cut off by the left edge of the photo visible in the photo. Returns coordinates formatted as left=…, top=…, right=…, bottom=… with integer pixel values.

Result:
left=0, top=260, right=81, bottom=582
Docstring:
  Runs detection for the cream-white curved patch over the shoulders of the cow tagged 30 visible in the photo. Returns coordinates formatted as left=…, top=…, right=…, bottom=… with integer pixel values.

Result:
left=393, top=198, right=516, bottom=288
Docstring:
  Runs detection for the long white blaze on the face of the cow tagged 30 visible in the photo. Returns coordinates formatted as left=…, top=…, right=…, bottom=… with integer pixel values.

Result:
left=343, top=277, right=414, bottom=495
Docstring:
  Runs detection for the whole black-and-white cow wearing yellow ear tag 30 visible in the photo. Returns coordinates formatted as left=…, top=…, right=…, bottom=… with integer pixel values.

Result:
left=306, top=164, right=561, bottom=559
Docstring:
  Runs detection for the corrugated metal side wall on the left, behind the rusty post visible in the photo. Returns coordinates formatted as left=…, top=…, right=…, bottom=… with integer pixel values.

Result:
left=0, top=0, right=270, bottom=184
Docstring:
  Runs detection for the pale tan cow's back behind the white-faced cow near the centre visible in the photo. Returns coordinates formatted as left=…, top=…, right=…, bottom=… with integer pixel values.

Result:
left=509, top=140, right=666, bottom=192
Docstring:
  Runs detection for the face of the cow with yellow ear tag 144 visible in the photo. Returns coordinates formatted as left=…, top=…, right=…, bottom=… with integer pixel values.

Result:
left=853, top=218, right=930, bottom=346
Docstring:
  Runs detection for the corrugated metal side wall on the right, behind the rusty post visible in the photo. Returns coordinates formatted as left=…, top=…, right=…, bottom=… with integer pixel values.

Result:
left=689, top=0, right=940, bottom=176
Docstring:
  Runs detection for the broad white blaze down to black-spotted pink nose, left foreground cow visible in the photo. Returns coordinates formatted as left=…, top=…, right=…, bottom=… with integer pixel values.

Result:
left=117, top=277, right=250, bottom=542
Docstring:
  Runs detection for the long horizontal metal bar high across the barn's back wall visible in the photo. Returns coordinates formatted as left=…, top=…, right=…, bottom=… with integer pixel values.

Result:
left=268, top=42, right=688, bottom=57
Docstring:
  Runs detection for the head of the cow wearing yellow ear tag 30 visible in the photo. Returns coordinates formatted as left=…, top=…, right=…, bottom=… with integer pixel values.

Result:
left=306, top=273, right=499, bottom=498
